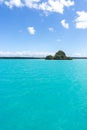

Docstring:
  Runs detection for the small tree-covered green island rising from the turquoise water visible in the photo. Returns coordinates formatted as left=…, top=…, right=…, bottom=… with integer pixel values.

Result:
left=45, top=50, right=72, bottom=60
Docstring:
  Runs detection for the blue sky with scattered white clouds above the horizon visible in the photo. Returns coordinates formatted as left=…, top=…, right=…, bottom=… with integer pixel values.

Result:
left=0, top=0, right=87, bottom=56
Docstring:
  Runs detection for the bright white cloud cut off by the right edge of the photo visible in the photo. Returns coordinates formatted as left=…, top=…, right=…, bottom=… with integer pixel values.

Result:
left=75, top=11, right=87, bottom=29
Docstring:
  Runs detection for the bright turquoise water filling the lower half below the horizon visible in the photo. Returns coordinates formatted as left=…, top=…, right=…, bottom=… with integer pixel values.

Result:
left=0, top=60, right=87, bottom=130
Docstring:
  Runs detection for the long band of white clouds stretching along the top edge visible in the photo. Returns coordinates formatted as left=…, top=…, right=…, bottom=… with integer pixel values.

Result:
left=0, top=0, right=74, bottom=14
